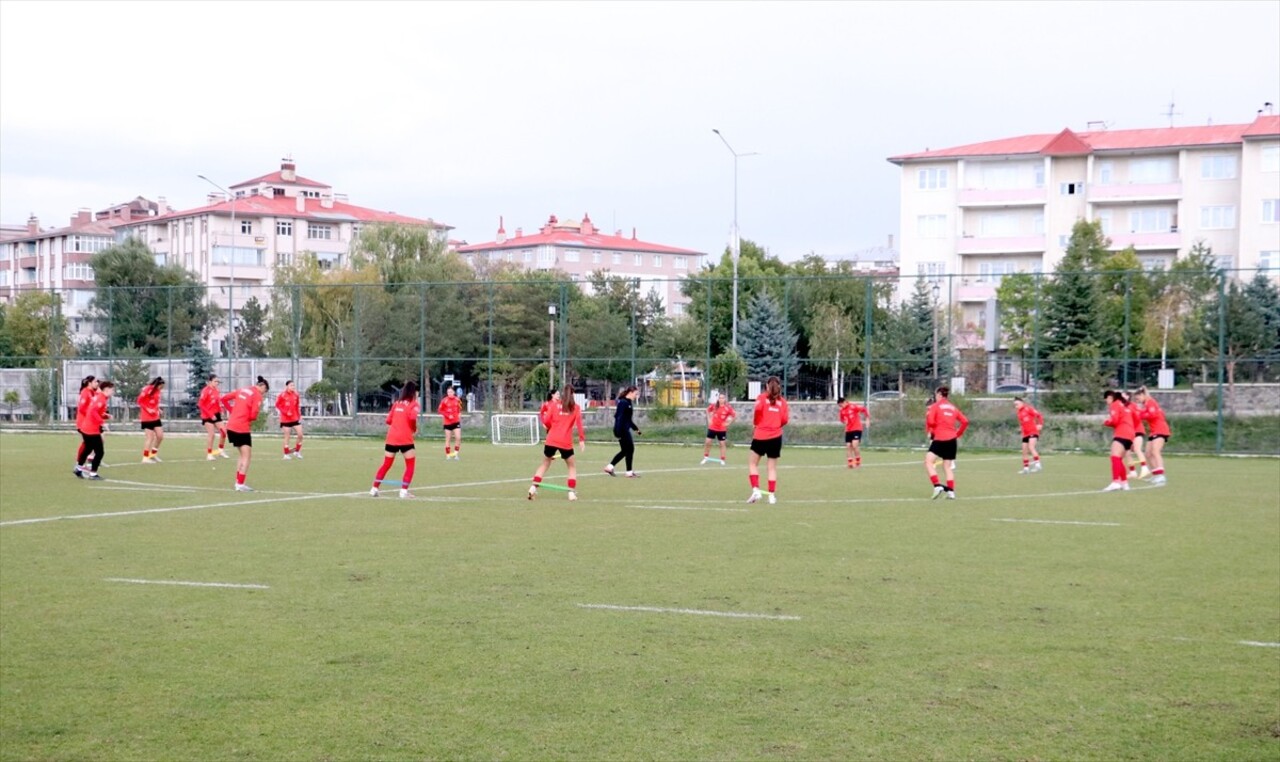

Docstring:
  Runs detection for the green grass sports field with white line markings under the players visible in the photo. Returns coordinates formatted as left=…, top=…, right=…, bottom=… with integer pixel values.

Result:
left=0, top=433, right=1280, bottom=761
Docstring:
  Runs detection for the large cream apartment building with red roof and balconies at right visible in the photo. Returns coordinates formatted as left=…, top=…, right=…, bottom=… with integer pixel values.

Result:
left=888, top=114, right=1280, bottom=343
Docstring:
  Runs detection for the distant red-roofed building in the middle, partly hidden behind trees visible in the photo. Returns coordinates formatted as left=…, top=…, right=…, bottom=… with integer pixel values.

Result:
left=457, top=213, right=705, bottom=316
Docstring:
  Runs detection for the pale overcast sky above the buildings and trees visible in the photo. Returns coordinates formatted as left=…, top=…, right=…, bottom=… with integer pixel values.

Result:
left=0, top=0, right=1280, bottom=260
